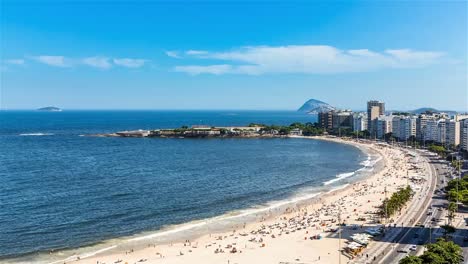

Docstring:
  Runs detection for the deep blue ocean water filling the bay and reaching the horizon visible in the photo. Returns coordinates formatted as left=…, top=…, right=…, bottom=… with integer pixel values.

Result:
left=0, top=111, right=371, bottom=262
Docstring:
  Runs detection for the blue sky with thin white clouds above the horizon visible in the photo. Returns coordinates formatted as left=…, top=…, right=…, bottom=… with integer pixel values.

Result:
left=0, top=0, right=468, bottom=111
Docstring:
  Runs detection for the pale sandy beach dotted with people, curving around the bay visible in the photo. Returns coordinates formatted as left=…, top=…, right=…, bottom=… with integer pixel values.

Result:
left=45, top=137, right=425, bottom=264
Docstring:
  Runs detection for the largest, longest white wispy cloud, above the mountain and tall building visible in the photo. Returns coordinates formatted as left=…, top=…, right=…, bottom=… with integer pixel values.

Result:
left=174, top=45, right=444, bottom=75
